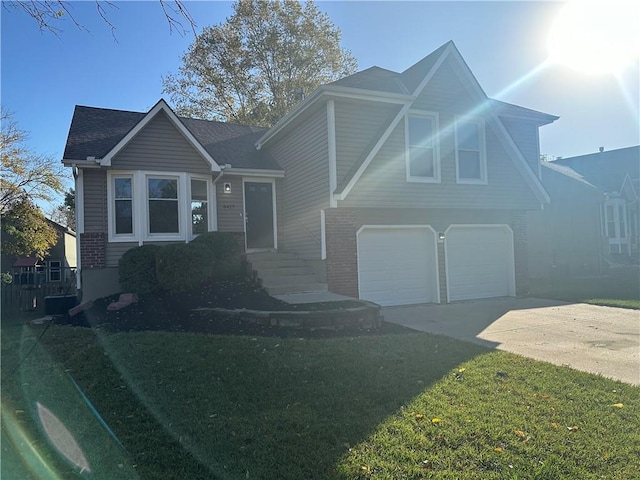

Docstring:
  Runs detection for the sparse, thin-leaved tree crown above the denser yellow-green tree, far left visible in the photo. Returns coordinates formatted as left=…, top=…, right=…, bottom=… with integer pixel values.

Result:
left=0, top=110, right=65, bottom=212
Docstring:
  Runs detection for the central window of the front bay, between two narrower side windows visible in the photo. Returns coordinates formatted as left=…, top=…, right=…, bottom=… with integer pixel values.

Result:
left=145, top=174, right=181, bottom=237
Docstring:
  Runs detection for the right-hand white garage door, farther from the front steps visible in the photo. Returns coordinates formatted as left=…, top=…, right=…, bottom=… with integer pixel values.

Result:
left=445, top=225, right=515, bottom=302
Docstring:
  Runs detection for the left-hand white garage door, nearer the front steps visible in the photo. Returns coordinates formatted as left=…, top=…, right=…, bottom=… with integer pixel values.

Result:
left=358, top=226, right=439, bottom=306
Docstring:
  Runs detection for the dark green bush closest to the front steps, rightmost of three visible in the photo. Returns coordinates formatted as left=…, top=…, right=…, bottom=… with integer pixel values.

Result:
left=191, top=232, right=243, bottom=279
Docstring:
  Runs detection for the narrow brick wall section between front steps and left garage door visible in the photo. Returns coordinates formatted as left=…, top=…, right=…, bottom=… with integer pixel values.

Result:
left=325, top=208, right=358, bottom=298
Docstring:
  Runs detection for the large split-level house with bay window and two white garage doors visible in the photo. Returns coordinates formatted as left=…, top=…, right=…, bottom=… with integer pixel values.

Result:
left=63, top=42, right=557, bottom=305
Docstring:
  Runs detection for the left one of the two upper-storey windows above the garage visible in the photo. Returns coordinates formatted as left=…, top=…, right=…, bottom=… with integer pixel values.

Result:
left=405, top=112, right=440, bottom=183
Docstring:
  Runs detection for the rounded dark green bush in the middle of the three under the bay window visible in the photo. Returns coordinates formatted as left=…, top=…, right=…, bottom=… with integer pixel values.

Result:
left=156, top=242, right=213, bottom=292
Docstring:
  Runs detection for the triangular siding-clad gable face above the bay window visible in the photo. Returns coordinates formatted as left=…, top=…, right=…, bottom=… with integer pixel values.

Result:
left=111, top=112, right=211, bottom=174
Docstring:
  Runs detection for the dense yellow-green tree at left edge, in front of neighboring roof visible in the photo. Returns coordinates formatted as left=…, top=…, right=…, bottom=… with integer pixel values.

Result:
left=1, top=196, right=58, bottom=259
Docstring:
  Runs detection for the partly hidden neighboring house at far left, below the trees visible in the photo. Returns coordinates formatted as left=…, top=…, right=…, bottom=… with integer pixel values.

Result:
left=2, top=219, right=77, bottom=285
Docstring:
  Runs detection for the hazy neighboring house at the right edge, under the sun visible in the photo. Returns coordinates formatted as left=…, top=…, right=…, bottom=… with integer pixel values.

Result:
left=553, top=146, right=640, bottom=263
